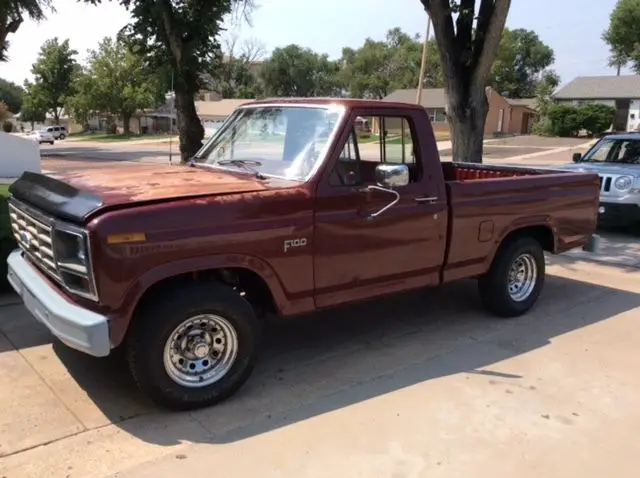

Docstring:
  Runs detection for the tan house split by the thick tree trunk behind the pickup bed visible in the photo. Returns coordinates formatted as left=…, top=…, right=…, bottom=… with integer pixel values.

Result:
left=382, top=87, right=536, bottom=136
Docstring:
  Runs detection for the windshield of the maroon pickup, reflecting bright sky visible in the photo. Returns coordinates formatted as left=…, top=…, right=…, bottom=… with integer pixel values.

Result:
left=195, top=106, right=344, bottom=181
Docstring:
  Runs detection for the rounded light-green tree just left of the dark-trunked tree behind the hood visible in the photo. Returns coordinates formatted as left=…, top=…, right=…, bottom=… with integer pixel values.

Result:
left=80, top=38, right=164, bottom=135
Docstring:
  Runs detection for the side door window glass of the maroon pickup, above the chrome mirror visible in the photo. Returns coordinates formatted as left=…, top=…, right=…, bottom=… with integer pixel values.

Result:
left=329, top=116, right=420, bottom=186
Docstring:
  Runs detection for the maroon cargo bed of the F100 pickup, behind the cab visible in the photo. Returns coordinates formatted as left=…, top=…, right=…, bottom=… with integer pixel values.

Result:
left=442, top=163, right=600, bottom=282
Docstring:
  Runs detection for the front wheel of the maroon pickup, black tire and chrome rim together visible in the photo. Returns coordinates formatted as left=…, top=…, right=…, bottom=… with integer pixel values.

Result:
left=126, top=283, right=260, bottom=410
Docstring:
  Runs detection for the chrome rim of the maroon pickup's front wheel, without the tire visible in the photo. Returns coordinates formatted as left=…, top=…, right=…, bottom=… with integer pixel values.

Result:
left=163, top=314, right=238, bottom=388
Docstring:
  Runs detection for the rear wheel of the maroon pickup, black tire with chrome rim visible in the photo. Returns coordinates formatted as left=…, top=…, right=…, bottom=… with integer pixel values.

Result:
left=478, top=237, right=545, bottom=318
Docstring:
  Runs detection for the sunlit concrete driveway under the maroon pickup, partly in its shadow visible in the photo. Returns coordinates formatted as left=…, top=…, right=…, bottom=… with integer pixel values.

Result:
left=0, top=234, right=640, bottom=478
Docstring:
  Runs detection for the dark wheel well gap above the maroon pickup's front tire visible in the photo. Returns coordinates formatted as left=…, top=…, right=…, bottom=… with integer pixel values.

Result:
left=136, top=267, right=277, bottom=316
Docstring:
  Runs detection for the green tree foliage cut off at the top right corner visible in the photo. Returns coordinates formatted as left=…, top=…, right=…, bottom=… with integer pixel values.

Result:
left=602, top=0, right=640, bottom=73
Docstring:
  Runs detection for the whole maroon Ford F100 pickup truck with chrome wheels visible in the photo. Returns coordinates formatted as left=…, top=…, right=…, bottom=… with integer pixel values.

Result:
left=8, top=99, right=599, bottom=409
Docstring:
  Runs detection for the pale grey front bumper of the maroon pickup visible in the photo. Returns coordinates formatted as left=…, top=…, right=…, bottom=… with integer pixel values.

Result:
left=7, top=249, right=111, bottom=357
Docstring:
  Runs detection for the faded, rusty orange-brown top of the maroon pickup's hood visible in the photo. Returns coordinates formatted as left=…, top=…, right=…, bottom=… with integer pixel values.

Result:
left=51, top=163, right=269, bottom=206
